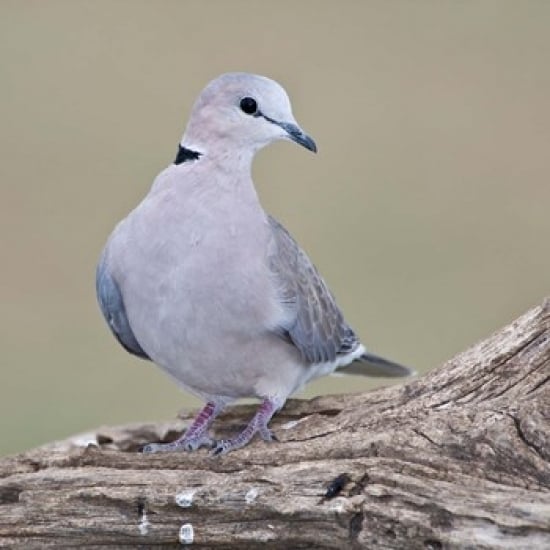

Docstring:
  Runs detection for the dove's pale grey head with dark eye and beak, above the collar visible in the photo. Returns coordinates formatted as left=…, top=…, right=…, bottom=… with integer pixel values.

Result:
left=181, top=73, right=317, bottom=154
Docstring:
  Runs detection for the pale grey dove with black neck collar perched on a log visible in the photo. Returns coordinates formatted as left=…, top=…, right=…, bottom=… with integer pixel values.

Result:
left=96, top=73, right=412, bottom=454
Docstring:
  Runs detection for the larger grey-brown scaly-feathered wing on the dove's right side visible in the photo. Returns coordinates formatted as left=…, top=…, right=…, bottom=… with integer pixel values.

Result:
left=268, top=216, right=360, bottom=364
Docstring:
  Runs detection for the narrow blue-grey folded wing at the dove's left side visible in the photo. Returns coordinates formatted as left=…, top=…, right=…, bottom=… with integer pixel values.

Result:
left=96, top=255, right=150, bottom=359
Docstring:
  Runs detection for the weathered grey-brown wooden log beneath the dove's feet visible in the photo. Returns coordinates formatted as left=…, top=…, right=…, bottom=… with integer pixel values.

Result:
left=0, top=300, right=550, bottom=550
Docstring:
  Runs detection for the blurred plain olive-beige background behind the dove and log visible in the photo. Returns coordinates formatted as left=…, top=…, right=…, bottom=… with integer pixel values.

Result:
left=0, top=0, right=550, bottom=454
